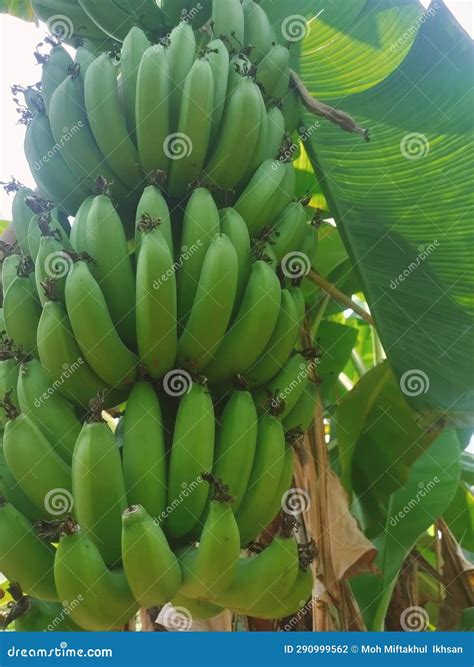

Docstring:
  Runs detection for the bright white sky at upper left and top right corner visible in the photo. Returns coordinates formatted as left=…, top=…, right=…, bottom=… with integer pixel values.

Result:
left=0, top=0, right=474, bottom=220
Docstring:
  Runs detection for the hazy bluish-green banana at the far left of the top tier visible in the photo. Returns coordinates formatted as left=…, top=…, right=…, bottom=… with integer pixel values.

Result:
left=25, top=112, right=87, bottom=215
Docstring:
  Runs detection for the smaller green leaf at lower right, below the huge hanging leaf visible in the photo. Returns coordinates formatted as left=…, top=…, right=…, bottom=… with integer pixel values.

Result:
left=353, top=430, right=461, bottom=630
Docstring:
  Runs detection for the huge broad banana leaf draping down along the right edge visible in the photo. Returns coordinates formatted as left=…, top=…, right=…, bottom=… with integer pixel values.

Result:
left=301, top=3, right=474, bottom=424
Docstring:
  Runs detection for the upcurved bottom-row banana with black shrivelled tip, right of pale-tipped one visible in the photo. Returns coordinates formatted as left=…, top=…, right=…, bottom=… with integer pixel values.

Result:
left=179, top=477, right=240, bottom=599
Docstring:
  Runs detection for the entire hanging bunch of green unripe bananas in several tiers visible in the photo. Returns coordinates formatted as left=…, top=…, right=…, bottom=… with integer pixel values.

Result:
left=0, top=0, right=317, bottom=630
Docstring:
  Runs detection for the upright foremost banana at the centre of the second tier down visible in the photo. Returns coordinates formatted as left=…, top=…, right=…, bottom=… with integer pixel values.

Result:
left=136, top=220, right=178, bottom=378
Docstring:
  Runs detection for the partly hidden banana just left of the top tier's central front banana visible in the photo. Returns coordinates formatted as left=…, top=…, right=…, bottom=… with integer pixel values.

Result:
left=120, top=26, right=150, bottom=137
